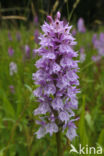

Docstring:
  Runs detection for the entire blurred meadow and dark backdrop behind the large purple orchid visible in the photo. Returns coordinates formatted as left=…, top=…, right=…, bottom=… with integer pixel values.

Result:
left=0, top=0, right=104, bottom=156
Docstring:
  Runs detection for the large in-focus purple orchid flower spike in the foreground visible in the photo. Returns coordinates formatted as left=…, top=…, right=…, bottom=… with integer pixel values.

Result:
left=33, top=12, right=79, bottom=140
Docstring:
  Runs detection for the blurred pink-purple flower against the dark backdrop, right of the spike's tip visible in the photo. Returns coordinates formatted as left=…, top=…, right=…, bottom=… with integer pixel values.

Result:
left=77, top=18, right=86, bottom=33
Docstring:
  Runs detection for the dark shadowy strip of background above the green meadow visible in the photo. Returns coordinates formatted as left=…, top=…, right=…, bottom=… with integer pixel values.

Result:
left=0, top=0, right=104, bottom=28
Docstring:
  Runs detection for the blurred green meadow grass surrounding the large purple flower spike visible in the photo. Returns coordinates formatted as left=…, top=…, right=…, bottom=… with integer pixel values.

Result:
left=0, top=27, right=104, bottom=156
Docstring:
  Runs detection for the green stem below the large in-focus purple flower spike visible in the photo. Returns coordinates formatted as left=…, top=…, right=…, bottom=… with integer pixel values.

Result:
left=56, top=131, right=62, bottom=156
